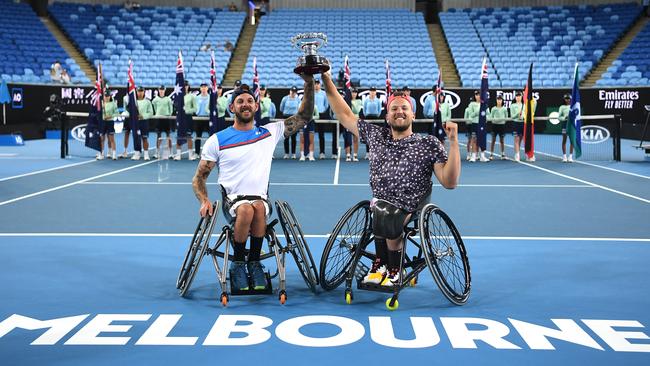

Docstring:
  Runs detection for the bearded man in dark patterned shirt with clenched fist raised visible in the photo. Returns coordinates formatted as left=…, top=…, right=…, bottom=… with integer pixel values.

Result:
left=322, top=73, right=460, bottom=286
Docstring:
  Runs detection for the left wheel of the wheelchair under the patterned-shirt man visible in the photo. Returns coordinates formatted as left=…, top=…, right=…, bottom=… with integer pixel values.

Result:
left=320, top=201, right=372, bottom=291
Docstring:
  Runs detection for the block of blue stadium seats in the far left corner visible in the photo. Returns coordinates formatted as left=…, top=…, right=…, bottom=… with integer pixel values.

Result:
left=0, top=0, right=88, bottom=83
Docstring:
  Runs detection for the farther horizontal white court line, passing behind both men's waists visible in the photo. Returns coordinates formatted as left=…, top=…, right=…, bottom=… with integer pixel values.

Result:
left=81, top=181, right=597, bottom=188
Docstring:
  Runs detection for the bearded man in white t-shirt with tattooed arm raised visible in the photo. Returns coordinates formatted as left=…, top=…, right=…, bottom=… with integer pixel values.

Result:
left=192, top=75, right=314, bottom=291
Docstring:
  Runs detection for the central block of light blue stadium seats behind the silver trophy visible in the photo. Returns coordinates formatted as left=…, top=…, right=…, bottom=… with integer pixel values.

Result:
left=242, top=9, right=438, bottom=88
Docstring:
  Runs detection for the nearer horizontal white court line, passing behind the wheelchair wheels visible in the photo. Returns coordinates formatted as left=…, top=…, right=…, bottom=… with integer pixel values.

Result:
left=0, top=233, right=650, bottom=243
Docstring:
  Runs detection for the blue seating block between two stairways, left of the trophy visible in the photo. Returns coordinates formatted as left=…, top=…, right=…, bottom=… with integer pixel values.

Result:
left=49, top=2, right=246, bottom=86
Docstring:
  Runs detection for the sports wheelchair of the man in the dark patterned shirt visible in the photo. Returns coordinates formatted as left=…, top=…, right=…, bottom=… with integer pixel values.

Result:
left=319, top=200, right=471, bottom=310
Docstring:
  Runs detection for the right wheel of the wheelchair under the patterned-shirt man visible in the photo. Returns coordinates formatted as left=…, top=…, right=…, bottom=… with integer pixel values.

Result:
left=419, top=203, right=471, bottom=305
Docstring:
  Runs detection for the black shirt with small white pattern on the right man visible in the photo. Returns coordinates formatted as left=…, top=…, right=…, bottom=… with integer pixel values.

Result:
left=357, top=120, right=447, bottom=212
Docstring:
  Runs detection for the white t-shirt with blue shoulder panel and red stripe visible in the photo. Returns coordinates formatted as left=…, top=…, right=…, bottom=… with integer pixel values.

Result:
left=201, top=122, right=284, bottom=198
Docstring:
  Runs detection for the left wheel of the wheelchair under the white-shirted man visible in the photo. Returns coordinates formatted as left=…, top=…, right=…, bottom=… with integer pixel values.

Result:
left=176, top=202, right=219, bottom=297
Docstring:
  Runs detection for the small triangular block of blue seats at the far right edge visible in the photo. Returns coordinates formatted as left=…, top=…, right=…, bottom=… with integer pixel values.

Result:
left=596, top=23, right=650, bottom=86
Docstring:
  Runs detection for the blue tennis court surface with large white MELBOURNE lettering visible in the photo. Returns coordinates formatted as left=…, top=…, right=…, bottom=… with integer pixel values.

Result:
left=0, top=141, right=650, bottom=365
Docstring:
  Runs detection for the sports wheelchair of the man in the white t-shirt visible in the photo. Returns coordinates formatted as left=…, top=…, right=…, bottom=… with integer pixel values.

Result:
left=176, top=194, right=319, bottom=306
